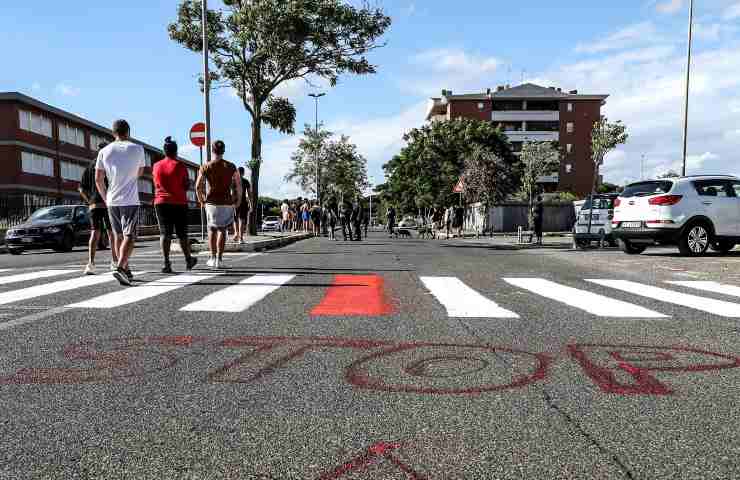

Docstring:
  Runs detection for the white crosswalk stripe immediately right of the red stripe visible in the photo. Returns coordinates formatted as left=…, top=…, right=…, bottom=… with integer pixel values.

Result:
left=421, top=277, right=519, bottom=318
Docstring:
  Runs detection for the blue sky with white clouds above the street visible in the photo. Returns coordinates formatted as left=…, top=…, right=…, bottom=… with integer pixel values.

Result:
left=0, top=0, right=740, bottom=197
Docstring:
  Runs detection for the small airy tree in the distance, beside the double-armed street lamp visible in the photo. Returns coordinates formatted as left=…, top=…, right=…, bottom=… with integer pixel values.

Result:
left=285, top=125, right=368, bottom=202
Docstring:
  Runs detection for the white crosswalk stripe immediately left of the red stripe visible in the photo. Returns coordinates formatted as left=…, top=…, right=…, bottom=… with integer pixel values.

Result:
left=180, top=275, right=295, bottom=313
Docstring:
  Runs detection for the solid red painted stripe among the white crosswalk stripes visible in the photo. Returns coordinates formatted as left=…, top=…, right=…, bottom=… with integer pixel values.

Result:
left=311, top=275, right=393, bottom=317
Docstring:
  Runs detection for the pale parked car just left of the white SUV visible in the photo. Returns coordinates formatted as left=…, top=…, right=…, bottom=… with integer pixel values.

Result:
left=573, top=193, right=619, bottom=248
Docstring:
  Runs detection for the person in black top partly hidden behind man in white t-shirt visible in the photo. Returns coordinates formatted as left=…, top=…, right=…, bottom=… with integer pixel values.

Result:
left=77, top=143, right=118, bottom=275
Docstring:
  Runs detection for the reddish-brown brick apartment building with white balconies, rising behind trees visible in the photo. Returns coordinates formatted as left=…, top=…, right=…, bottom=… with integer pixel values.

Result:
left=427, top=83, right=608, bottom=196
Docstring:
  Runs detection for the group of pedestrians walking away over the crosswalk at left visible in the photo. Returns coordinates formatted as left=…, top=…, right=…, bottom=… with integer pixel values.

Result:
left=79, top=120, right=251, bottom=286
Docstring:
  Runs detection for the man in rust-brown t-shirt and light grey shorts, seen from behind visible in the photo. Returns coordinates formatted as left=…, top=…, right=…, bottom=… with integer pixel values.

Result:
left=195, top=140, right=242, bottom=268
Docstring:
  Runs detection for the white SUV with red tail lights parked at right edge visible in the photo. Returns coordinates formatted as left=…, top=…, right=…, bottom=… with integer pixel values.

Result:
left=612, top=175, right=740, bottom=256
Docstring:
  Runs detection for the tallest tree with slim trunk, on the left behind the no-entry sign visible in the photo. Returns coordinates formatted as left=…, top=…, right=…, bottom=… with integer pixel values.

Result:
left=168, top=0, right=391, bottom=234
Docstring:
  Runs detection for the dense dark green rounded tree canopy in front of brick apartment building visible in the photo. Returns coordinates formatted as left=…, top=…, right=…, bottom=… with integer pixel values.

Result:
left=378, top=119, right=517, bottom=214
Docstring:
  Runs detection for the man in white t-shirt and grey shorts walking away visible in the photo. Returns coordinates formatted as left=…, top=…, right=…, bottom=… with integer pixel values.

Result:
left=95, top=120, right=146, bottom=286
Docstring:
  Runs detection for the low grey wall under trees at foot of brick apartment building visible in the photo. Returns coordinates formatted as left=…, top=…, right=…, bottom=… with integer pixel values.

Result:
left=465, top=203, right=576, bottom=233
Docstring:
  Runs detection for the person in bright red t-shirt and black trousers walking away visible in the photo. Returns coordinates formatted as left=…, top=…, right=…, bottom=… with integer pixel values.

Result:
left=152, top=137, right=198, bottom=273
